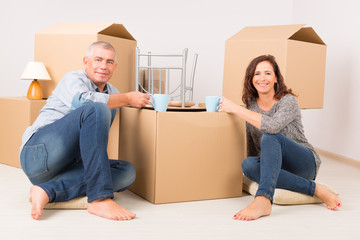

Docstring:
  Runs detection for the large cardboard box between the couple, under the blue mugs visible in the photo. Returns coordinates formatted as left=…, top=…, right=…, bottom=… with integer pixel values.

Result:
left=120, top=107, right=245, bottom=204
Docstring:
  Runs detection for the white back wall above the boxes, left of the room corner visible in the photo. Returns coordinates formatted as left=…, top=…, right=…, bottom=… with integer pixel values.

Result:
left=0, top=0, right=292, bottom=99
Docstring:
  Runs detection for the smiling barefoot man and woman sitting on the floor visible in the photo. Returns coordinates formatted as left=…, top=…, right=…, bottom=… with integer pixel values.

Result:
left=20, top=42, right=341, bottom=220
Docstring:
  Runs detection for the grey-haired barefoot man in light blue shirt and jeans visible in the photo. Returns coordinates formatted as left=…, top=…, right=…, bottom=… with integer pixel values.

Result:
left=20, top=42, right=149, bottom=220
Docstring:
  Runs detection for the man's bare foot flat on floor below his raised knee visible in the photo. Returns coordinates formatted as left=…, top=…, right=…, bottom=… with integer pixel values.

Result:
left=87, top=198, right=136, bottom=220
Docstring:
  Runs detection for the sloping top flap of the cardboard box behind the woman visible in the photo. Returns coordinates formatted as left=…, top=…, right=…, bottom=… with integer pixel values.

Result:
left=228, top=24, right=306, bottom=40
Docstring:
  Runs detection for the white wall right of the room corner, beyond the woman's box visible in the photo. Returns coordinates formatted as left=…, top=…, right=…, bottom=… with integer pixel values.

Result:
left=293, top=0, right=360, bottom=161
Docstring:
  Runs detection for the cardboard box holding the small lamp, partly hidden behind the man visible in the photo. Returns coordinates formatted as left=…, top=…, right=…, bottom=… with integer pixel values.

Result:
left=0, top=97, right=120, bottom=168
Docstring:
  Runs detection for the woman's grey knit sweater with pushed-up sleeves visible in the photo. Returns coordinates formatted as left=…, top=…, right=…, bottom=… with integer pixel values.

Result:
left=246, top=94, right=321, bottom=176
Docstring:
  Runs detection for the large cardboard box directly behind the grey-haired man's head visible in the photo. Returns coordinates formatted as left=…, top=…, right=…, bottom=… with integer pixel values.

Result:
left=35, top=23, right=136, bottom=98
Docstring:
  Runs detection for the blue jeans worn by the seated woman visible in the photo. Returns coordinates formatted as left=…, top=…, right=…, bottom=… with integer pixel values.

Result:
left=242, top=133, right=316, bottom=202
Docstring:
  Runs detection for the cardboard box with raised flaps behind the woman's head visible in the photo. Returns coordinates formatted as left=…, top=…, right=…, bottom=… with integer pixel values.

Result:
left=223, top=24, right=326, bottom=108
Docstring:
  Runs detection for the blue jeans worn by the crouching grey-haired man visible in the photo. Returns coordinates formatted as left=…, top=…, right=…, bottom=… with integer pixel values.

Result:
left=20, top=102, right=135, bottom=202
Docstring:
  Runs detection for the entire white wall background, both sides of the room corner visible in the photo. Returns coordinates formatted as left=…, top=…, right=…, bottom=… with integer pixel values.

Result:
left=0, top=0, right=360, bottom=163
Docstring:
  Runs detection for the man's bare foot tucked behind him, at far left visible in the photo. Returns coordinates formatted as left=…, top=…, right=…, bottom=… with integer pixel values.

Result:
left=30, top=185, right=49, bottom=220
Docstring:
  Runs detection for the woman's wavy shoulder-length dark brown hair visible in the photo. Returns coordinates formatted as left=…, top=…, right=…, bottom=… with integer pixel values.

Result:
left=242, top=55, right=295, bottom=106
